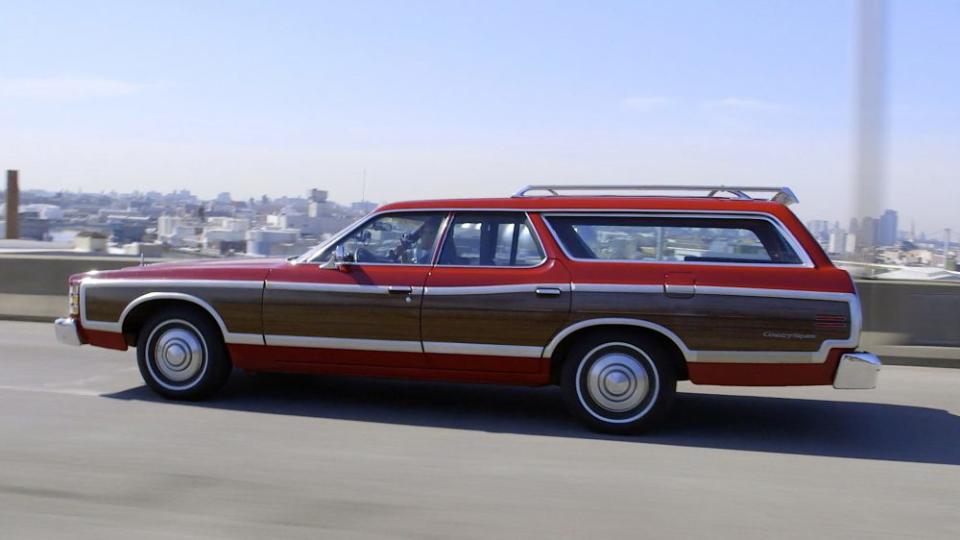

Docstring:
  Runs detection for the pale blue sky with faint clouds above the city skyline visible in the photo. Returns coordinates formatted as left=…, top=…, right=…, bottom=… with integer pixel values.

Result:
left=0, top=0, right=960, bottom=231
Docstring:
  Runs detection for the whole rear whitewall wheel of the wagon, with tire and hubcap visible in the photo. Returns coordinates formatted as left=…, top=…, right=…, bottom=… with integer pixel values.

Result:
left=561, top=332, right=677, bottom=434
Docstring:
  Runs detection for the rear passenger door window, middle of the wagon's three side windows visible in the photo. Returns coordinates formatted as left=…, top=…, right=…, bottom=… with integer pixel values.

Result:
left=438, top=212, right=544, bottom=266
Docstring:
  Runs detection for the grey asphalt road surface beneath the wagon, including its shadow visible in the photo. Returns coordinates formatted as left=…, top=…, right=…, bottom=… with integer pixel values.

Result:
left=0, top=322, right=960, bottom=539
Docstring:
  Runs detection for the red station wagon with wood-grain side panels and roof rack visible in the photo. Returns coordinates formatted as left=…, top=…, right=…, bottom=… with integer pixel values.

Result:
left=55, top=186, right=880, bottom=433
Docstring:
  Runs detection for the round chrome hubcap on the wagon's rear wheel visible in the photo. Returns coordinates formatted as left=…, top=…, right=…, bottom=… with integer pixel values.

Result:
left=586, top=352, right=650, bottom=413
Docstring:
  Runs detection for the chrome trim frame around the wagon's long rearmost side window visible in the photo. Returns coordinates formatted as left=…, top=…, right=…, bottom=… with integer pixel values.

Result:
left=540, top=210, right=815, bottom=268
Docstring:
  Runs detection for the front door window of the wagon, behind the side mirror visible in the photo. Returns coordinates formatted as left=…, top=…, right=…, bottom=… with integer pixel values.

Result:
left=319, top=212, right=446, bottom=264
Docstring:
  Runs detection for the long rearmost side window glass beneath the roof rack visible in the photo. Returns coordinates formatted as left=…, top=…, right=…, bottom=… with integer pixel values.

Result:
left=545, top=215, right=802, bottom=264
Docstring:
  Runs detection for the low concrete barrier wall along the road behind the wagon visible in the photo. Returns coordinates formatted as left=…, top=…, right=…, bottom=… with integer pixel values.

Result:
left=0, top=254, right=960, bottom=367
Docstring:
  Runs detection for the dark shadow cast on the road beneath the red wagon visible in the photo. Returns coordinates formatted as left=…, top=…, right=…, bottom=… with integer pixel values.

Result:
left=104, top=373, right=960, bottom=465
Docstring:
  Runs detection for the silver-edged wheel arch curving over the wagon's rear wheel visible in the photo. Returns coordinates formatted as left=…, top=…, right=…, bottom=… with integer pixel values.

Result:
left=543, top=317, right=696, bottom=383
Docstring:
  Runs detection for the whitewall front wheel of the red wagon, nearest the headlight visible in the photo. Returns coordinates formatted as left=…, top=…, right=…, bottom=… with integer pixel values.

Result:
left=137, top=307, right=232, bottom=401
